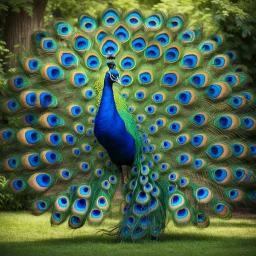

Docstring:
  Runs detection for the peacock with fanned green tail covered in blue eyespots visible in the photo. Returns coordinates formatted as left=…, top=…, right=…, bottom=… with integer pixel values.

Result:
left=0, top=8, right=256, bottom=241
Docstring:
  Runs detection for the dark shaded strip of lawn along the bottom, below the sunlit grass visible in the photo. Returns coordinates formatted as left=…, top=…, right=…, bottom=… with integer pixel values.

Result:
left=0, top=234, right=256, bottom=256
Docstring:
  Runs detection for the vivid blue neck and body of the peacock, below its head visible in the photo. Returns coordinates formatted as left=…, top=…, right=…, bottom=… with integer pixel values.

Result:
left=94, top=75, right=135, bottom=165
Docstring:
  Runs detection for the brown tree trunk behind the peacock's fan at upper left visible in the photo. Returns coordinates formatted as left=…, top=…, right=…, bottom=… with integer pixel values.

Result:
left=4, top=0, right=48, bottom=68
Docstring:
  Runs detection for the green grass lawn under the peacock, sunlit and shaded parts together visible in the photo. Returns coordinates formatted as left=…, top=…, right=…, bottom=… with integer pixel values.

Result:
left=0, top=204, right=256, bottom=256
